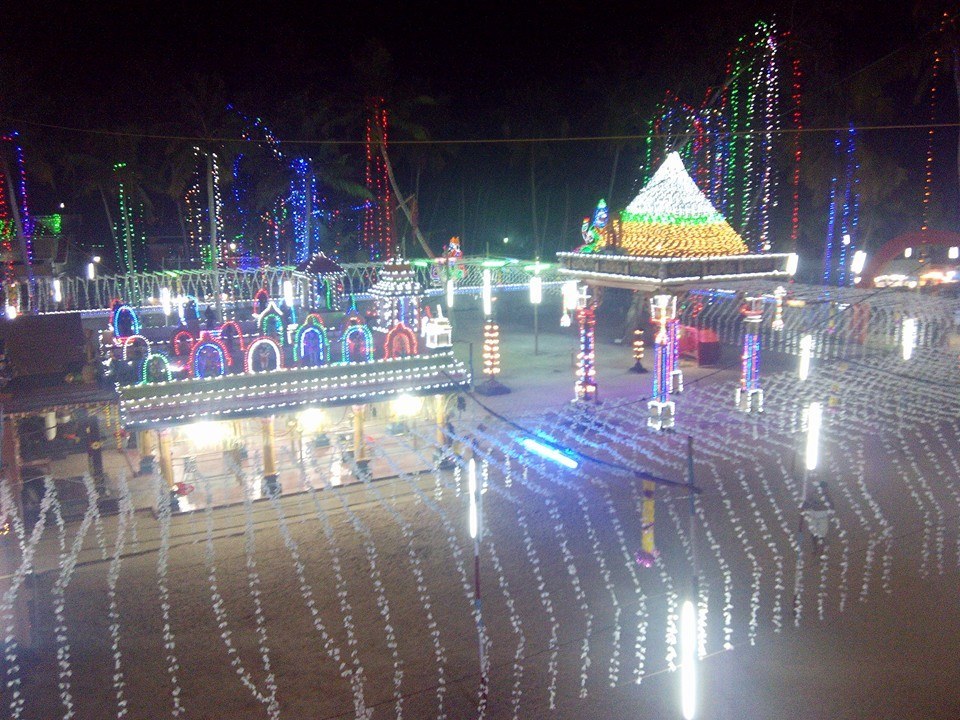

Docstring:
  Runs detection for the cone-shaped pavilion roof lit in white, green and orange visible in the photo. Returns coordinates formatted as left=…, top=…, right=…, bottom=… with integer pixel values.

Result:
left=593, top=152, right=747, bottom=257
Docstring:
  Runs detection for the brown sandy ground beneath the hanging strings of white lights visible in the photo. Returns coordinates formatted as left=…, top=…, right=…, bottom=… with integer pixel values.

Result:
left=2, top=300, right=960, bottom=719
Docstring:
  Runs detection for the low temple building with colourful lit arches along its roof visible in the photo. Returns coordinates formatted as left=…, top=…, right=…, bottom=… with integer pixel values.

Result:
left=0, top=262, right=471, bottom=507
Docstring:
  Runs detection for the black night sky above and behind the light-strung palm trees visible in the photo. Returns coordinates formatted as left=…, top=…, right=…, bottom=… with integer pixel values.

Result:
left=0, top=0, right=956, bottom=264
